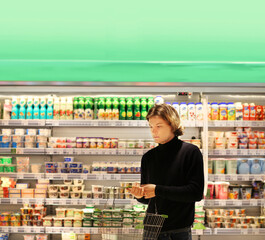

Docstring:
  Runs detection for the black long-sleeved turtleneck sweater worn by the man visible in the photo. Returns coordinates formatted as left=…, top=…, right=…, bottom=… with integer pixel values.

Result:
left=138, top=137, right=204, bottom=232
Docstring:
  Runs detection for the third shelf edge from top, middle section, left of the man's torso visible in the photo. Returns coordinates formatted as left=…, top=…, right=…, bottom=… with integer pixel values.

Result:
left=45, top=173, right=140, bottom=180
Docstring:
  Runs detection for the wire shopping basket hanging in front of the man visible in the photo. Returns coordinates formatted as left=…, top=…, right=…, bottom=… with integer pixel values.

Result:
left=101, top=195, right=167, bottom=240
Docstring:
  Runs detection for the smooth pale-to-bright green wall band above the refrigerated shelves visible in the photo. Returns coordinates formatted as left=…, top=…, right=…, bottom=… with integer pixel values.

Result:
left=0, top=0, right=265, bottom=82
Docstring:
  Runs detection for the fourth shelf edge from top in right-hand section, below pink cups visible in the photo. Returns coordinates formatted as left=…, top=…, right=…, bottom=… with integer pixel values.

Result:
left=204, top=199, right=265, bottom=207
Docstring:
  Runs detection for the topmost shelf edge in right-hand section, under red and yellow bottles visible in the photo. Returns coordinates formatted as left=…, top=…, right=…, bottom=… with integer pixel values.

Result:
left=208, top=121, right=265, bottom=127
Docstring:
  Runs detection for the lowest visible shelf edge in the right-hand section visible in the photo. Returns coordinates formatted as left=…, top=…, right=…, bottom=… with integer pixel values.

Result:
left=212, top=228, right=265, bottom=235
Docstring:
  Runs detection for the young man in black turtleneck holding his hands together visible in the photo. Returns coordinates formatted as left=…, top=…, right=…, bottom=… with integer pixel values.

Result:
left=128, top=104, right=204, bottom=240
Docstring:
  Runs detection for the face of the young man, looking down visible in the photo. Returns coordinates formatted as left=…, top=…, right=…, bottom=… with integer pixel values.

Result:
left=149, top=116, right=175, bottom=144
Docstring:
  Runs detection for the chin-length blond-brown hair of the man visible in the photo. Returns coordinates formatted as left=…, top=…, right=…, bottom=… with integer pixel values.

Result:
left=146, top=104, right=184, bottom=136
